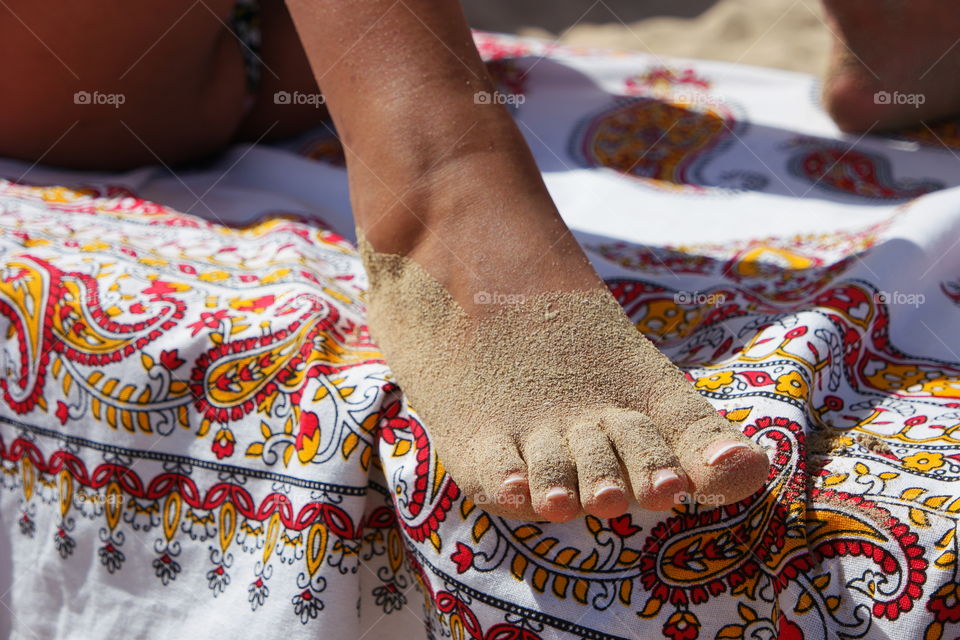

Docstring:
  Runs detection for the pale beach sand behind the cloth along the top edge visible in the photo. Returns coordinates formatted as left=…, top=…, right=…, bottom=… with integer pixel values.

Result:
left=463, top=0, right=833, bottom=73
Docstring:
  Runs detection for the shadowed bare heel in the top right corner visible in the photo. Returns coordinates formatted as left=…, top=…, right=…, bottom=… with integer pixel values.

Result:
left=823, top=0, right=960, bottom=132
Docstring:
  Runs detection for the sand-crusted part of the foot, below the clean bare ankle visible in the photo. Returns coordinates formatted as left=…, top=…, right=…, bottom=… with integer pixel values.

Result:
left=360, top=236, right=768, bottom=520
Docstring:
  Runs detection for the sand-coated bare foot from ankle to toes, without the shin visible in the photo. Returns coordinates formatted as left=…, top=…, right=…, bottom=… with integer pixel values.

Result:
left=362, top=156, right=769, bottom=521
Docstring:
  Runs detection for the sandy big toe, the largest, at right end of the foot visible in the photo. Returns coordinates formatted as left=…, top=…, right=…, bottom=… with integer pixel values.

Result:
left=661, top=413, right=770, bottom=505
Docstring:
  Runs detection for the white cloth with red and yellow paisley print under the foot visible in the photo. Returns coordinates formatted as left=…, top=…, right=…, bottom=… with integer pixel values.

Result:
left=0, top=34, right=960, bottom=640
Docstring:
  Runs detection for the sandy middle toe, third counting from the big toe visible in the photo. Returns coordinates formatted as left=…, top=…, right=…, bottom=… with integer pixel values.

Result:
left=567, top=420, right=630, bottom=518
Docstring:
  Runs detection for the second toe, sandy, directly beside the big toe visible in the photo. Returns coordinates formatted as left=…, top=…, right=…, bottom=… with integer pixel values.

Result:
left=602, top=411, right=688, bottom=511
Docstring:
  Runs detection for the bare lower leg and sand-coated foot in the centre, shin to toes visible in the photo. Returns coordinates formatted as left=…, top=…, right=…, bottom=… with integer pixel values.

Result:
left=276, top=0, right=769, bottom=521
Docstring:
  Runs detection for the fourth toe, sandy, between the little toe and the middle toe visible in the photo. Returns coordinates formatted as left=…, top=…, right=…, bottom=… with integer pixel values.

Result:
left=523, top=429, right=581, bottom=522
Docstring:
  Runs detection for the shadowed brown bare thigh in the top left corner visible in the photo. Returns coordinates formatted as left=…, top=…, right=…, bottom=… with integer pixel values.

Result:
left=0, top=0, right=246, bottom=169
